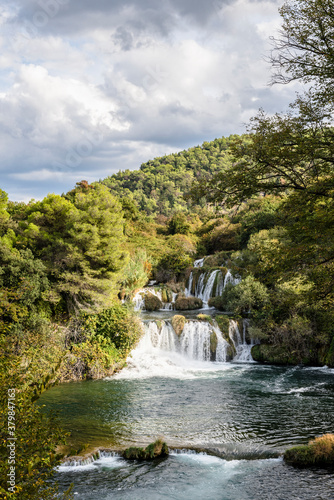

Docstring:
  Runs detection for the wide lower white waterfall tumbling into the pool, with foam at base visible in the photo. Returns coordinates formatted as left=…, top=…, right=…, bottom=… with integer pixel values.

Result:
left=114, top=320, right=253, bottom=379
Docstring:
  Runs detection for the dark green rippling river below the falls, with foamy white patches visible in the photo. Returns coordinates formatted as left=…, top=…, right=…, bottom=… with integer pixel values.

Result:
left=40, top=314, right=334, bottom=500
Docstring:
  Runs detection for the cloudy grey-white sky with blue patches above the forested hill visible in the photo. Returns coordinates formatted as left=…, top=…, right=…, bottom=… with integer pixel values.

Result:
left=0, top=0, right=295, bottom=202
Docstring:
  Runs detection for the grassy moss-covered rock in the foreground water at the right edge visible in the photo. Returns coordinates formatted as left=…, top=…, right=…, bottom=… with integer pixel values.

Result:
left=284, top=434, right=334, bottom=469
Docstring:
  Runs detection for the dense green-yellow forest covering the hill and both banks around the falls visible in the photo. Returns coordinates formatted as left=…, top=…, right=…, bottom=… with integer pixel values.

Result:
left=0, top=0, right=334, bottom=499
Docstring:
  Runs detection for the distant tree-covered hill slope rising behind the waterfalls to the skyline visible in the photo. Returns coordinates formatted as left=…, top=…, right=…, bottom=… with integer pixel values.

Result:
left=101, top=136, right=236, bottom=217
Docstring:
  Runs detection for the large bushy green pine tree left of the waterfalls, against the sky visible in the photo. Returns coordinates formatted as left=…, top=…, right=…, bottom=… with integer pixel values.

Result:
left=17, top=182, right=127, bottom=312
